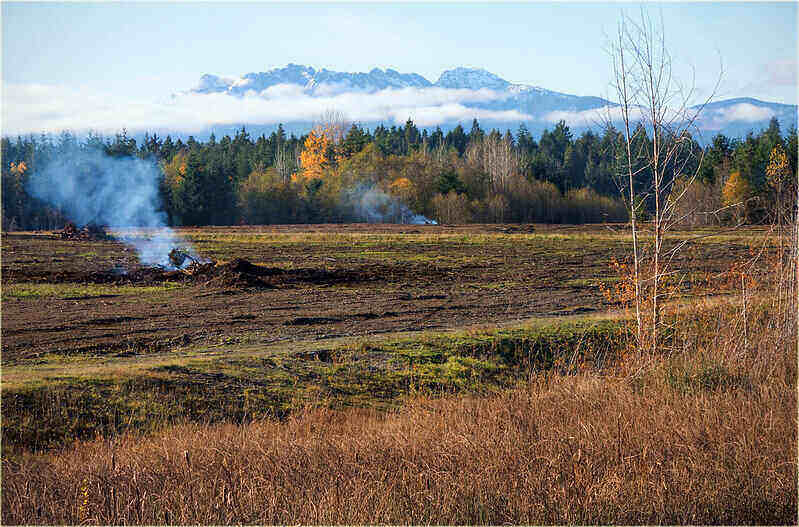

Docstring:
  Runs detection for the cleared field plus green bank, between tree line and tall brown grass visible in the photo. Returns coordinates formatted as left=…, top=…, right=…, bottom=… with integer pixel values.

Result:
left=2, top=224, right=763, bottom=450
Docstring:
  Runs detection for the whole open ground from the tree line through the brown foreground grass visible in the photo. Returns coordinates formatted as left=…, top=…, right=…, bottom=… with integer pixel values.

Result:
left=1, top=225, right=797, bottom=525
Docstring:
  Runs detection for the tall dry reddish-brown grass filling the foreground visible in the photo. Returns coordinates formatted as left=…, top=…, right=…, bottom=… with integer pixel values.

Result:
left=2, top=294, right=797, bottom=524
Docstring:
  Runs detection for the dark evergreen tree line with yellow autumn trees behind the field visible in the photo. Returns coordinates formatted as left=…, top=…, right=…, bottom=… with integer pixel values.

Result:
left=2, top=119, right=797, bottom=230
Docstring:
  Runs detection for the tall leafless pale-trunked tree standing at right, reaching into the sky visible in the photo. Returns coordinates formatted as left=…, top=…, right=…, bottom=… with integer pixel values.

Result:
left=608, top=9, right=721, bottom=351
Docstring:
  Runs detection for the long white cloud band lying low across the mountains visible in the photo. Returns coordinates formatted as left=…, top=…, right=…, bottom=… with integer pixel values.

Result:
left=2, top=84, right=531, bottom=135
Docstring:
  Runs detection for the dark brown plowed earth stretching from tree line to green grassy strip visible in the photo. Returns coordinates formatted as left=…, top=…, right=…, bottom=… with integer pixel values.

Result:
left=2, top=225, right=748, bottom=364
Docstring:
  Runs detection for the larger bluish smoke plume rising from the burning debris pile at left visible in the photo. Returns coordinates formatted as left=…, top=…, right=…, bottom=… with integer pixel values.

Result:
left=28, top=147, right=193, bottom=268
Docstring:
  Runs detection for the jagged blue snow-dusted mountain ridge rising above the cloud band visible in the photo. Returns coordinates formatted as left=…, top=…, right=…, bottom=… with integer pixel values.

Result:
left=184, top=63, right=797, bottom=141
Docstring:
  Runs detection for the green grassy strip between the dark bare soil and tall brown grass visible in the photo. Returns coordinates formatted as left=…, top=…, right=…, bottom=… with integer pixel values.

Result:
left=2, top=321, right=622, bottom=450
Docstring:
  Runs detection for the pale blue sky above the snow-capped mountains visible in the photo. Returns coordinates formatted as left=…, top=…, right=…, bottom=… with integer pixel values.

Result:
left=2, top=2, right=797, bottom=133
